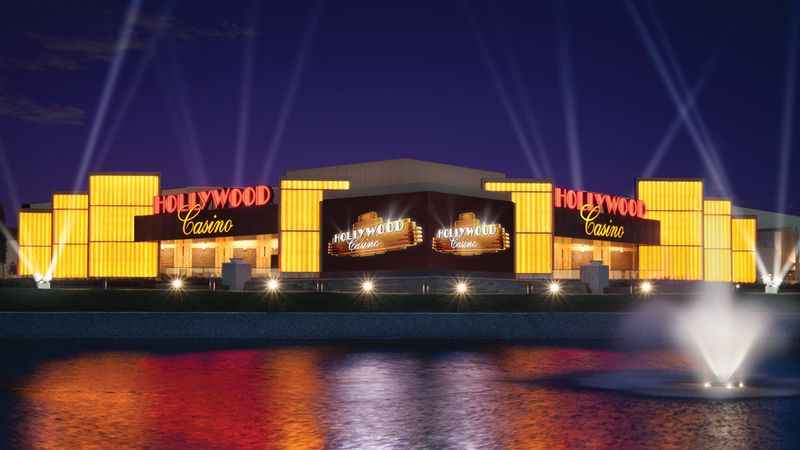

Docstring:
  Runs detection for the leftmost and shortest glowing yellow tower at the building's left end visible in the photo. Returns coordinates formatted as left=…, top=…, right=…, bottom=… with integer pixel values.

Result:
left=17, top=211, right=52, bottom=275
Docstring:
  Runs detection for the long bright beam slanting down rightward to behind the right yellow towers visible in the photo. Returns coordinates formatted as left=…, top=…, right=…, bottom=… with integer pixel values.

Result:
left=625, top=0, right=730, bottom=196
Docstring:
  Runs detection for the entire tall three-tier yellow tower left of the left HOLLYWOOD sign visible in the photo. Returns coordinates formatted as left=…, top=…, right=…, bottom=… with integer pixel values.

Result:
left=89, top=174, right=160, bottom=277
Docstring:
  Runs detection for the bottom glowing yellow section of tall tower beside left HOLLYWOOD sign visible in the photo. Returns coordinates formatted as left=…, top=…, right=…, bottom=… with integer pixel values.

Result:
left=89, top=242, right=158, bottom=277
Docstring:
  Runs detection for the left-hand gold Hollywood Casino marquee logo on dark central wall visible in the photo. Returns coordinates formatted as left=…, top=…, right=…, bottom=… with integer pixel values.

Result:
left=328, top=211, right=422, bottom=256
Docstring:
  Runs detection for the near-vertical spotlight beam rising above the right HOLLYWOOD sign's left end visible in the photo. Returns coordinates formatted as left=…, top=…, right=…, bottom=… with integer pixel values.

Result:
left=555, top=0, right=583, bottom=189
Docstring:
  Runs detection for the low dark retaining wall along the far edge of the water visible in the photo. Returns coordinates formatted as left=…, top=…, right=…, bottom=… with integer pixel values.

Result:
left=0, top=312, right=800, bottom=342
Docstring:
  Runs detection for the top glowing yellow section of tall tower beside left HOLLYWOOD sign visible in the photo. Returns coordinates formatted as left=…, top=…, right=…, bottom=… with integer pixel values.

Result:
left=89, top=174, right=160, bottom=206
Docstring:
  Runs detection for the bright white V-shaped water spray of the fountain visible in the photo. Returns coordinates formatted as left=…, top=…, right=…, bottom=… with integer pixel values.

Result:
left=672, top=288, right=771, bottom=386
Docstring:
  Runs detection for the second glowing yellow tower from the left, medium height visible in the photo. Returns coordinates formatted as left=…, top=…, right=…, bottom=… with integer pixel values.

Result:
left=53, top=194, right=89, bottom=278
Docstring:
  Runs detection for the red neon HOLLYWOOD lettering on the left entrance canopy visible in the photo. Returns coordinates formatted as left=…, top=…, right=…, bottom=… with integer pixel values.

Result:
left=153, top=185, right=272, bottom=214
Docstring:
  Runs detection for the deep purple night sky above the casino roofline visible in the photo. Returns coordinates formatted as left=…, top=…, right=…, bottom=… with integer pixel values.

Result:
left=0, top=0, right=800, bottom=224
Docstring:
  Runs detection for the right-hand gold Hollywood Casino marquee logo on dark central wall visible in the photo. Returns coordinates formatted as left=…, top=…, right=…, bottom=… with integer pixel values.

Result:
left=433, top=212, right=511, bottom=256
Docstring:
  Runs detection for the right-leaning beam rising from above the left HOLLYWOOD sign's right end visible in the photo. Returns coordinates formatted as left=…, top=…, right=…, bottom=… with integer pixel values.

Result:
left=261, top=0, right=325, bottom=182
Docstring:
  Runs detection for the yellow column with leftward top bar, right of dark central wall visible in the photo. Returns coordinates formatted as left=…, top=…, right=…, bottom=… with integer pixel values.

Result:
left=483, top=180, right=553, bottom=275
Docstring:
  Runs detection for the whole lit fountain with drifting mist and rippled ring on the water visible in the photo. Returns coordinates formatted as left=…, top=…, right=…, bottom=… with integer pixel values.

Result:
left=573, top=285, right=800, bottom=399
